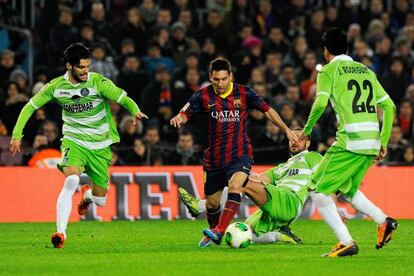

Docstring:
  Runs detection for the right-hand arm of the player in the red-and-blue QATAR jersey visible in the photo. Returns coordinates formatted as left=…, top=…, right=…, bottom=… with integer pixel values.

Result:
left=247, top=89, right=298, bottom=143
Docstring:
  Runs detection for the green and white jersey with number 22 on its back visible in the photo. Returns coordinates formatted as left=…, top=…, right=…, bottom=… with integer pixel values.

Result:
left=304, top=55, right=393, bottom=155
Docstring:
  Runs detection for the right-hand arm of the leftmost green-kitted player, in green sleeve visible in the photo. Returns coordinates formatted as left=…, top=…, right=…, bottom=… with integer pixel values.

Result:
left=98, top=77, right=148, bottom=124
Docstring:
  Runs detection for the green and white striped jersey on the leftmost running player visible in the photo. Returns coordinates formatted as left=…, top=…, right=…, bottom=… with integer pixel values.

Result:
left=13, top=73, right=139, bottom=150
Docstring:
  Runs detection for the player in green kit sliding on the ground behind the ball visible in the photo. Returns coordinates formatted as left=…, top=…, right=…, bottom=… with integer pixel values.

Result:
left=179, top=130, right=322, bottom=244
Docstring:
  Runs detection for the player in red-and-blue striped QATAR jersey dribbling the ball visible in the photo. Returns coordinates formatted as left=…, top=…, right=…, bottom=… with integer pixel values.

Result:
left=171, top=58, right=298, bottom=247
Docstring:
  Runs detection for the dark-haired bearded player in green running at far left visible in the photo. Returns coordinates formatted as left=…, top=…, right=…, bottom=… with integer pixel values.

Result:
left=10, top=43, right=148, bottom=248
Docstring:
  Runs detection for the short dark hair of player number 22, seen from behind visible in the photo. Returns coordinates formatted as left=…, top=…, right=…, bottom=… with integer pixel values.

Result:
left=322, top=28, right=348, bottom=56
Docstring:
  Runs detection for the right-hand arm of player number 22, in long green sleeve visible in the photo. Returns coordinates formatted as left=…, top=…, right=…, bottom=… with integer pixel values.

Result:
left=376, top=77, right=396, bottom=160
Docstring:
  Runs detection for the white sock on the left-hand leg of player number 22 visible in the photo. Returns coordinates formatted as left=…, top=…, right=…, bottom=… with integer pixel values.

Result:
left=310, top=192, right=353, bottom=245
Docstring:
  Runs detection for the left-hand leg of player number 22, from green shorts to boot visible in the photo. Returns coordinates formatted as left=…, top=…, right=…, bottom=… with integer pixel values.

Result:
left=310, top=147, right=360, bottom=257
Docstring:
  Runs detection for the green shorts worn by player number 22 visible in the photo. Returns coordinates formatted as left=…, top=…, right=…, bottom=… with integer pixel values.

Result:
left=309, top=147, right=375, bottom=198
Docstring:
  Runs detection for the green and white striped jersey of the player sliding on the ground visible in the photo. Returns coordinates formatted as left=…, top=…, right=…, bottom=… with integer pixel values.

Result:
left=266, top=150, right=322, bottom=204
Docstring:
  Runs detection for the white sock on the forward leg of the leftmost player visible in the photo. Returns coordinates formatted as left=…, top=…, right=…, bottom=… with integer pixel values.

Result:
left=56, top=175, right=80, bottom=239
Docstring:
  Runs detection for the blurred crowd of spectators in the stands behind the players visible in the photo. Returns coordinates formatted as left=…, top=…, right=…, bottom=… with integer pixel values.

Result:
left=0, top=0, right=414, bottom=165
